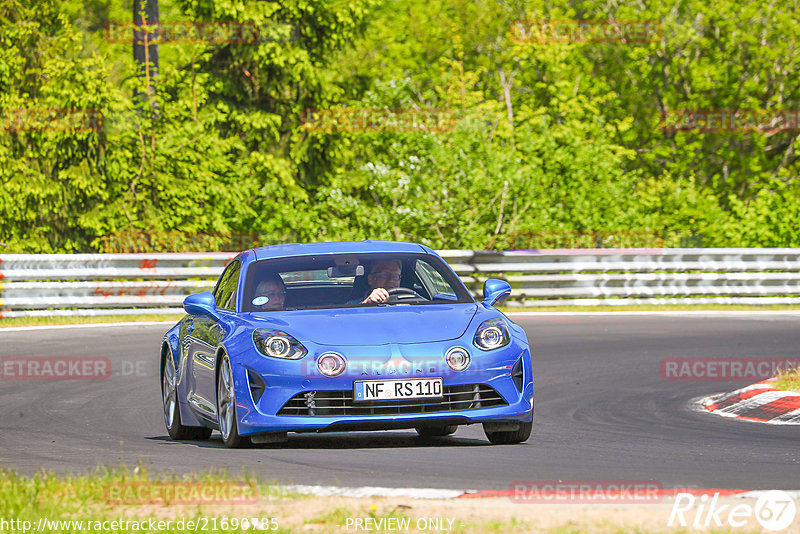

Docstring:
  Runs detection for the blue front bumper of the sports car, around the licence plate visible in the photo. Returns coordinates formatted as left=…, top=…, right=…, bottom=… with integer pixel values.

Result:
left=228, top=340, right=533, bottom=436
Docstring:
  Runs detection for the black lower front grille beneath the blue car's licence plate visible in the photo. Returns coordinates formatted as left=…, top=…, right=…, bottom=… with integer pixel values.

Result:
left=278, top=384, right=508, bottom=417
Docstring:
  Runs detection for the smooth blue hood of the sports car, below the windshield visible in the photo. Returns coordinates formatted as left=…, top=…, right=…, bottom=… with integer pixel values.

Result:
left=251, top=303, right=478, bottom=346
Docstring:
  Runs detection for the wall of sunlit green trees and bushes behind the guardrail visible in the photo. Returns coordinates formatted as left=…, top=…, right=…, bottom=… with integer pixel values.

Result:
left=0, top=0, right=800, bottom=252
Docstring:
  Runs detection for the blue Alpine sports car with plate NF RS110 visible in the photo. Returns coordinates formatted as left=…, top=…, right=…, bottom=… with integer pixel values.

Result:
left=161, top=241, right=533, bottom=447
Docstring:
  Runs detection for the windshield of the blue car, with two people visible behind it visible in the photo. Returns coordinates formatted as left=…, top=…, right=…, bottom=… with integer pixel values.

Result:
left=242, top=254, right=474, bottom=312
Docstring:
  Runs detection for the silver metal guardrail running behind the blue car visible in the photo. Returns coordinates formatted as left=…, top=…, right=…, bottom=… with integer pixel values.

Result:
left=0, top=248, right=800, bottom=317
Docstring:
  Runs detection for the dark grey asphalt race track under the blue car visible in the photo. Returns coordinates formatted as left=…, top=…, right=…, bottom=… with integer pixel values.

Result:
left=0, top=314, right=800, bottom=489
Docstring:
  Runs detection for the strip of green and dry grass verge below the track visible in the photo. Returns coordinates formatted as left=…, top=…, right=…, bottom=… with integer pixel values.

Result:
left=0, top=472, right=752, bottom=534
